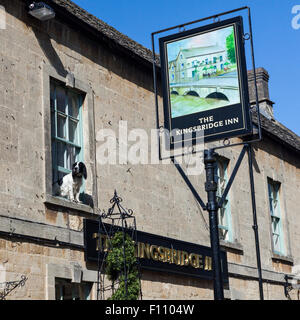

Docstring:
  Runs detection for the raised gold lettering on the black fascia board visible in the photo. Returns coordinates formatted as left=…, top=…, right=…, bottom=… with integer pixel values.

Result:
left=92, top=233, right=212, bottom=271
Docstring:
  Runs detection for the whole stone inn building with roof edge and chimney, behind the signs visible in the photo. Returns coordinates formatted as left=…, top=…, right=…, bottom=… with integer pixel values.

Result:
left=0, top=0, right=300, bottom=299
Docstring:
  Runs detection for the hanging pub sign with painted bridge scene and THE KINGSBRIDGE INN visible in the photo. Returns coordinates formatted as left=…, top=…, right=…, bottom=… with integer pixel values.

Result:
left=159, top=17, right=252, bottom=148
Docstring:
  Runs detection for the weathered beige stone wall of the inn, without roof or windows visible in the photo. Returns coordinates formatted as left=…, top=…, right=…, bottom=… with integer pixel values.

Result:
left=0, top=0, right=300, bottom=299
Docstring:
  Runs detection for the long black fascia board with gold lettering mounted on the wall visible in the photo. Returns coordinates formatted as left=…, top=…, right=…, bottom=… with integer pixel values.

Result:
left=84, top=219, right=228, bottom=283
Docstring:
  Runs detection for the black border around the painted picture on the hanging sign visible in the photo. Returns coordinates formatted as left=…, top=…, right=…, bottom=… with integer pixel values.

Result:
left=159, top=16, right=253, bottom=150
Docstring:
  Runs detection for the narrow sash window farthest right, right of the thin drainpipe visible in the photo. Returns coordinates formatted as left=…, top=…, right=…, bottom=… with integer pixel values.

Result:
left=268, top=178, right=284, bottom=255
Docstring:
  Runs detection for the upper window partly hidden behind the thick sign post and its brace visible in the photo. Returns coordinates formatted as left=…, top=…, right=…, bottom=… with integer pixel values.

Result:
left=215, top=157, right=232, bottom=241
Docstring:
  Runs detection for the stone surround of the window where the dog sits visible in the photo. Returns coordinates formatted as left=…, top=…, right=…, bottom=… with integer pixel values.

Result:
left=42, top=64, right=98, bottom=214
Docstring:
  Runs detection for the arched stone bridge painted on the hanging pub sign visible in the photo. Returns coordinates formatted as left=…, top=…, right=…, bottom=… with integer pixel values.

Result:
left=170, top=76, right=239, bottom=102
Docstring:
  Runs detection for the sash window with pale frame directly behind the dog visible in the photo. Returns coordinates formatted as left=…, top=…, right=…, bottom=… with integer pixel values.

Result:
left=50, top=81, right=83, bottom=190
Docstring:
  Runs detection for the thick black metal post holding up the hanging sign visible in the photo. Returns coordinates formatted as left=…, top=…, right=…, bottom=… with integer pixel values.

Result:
left=204, top=149, right=224, bottom=300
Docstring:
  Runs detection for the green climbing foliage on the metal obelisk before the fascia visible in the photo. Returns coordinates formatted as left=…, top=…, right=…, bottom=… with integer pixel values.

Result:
left=106, top=232, right=140, bottom=300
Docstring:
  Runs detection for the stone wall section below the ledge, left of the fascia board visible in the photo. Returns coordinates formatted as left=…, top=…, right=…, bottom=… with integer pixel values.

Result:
left=0, top=239, right=88, bottom=300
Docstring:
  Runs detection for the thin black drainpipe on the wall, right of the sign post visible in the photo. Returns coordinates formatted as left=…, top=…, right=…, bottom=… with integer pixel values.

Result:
left=247, top=144, right=264, bottom=300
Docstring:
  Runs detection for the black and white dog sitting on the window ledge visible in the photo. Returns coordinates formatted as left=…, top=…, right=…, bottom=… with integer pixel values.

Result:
left=54, top=162, right=87, bottom=203
